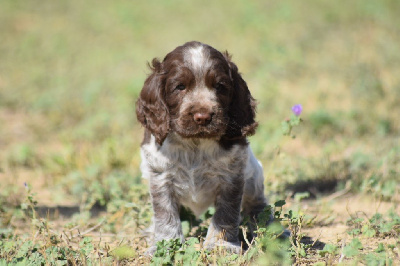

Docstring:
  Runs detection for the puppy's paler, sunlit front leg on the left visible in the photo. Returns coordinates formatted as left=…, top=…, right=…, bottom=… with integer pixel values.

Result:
left=147, top=179, right=184, bottom=255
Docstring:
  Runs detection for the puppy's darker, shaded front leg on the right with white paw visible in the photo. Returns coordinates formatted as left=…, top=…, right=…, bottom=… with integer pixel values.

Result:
left=204, top=177, right=244, bottom=253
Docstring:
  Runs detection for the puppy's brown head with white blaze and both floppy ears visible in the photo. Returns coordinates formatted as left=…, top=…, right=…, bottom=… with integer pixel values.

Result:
left=136, top=42, right=257, bottom=145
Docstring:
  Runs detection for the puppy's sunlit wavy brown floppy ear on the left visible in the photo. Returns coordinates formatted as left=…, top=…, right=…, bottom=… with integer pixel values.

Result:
left=136, top=58, right=170, bottom=145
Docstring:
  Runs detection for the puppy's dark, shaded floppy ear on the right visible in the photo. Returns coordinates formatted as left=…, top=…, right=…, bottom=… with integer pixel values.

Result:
left=223, top=52, right=258, bottom=139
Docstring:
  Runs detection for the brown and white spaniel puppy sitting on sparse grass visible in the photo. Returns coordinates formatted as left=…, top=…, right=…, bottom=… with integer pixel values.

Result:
left=136, top=42, right=266, bottom=253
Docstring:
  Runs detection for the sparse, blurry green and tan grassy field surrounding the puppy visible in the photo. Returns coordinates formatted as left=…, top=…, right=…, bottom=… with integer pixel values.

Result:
left=0, top=0, right=400, bottom=265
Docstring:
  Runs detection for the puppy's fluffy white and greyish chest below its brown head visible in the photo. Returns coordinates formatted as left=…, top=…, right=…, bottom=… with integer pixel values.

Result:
left=142, top=137, right=247, bottom=216
